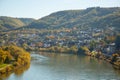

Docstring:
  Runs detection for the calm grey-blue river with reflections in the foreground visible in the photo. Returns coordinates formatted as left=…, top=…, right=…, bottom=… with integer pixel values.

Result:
left=2, top=52, right=120, bottom=80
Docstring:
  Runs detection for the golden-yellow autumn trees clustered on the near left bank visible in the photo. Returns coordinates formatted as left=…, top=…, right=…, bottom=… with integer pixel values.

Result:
left=0, top=45, right=31, bottom=66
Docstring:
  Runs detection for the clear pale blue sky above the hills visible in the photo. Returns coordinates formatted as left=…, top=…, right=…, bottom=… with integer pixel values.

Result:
left=0, top=0, right=120, bottom=19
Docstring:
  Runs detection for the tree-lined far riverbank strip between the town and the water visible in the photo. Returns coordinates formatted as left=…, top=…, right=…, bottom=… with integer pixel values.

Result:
left=34, top=46, right=120, bottom=70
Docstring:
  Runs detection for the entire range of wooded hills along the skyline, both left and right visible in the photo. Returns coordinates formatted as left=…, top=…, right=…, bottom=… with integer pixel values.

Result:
left=0, top=7, right=120, bottom=31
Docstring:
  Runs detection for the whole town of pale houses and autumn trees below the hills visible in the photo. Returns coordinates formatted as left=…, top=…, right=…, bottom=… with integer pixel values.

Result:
left=0, top=27, right=119, bottom=55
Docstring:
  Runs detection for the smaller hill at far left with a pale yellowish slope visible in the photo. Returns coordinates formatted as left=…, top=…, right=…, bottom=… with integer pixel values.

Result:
left=0, top=16, right=34, bottom=31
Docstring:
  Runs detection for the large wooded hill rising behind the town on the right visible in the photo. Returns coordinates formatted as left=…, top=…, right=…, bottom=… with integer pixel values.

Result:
left=26, top=7, right=120, bottom=29
